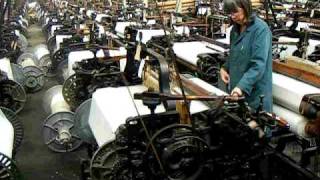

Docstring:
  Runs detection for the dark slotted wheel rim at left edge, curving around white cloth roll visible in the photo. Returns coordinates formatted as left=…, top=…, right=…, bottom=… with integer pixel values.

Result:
left=0, top=107, right=24, bottom=153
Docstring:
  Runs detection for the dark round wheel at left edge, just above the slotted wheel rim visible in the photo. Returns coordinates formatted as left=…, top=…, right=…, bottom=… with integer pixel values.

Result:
left=0, top=80, right=27, bottom=113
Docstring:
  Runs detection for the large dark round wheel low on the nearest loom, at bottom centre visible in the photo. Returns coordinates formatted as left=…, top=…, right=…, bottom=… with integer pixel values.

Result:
left=148, top=124, right=209, bottom=180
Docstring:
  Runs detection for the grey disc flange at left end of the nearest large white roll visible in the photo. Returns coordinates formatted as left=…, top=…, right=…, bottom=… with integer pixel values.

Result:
left=74, top=98, right=96, bottom=144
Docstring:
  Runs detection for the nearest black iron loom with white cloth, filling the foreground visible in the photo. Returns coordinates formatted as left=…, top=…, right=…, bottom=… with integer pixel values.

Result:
left=74, top=46, right=319, bottom=180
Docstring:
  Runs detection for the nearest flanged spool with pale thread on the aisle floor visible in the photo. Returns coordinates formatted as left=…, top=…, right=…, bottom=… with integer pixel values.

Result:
left=42, top=85, right=82, bottom=152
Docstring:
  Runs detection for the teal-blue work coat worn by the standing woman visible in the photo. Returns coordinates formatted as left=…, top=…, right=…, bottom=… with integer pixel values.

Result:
left=223, top=16, right=272, bottom=112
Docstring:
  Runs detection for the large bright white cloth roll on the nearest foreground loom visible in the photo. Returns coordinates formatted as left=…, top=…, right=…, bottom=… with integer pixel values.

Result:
left=89, top=85, right=164, bottom=146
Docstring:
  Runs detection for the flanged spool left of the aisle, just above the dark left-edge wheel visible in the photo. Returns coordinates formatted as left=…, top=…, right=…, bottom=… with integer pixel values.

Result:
left=17, top=52, right=44, bottom=92
